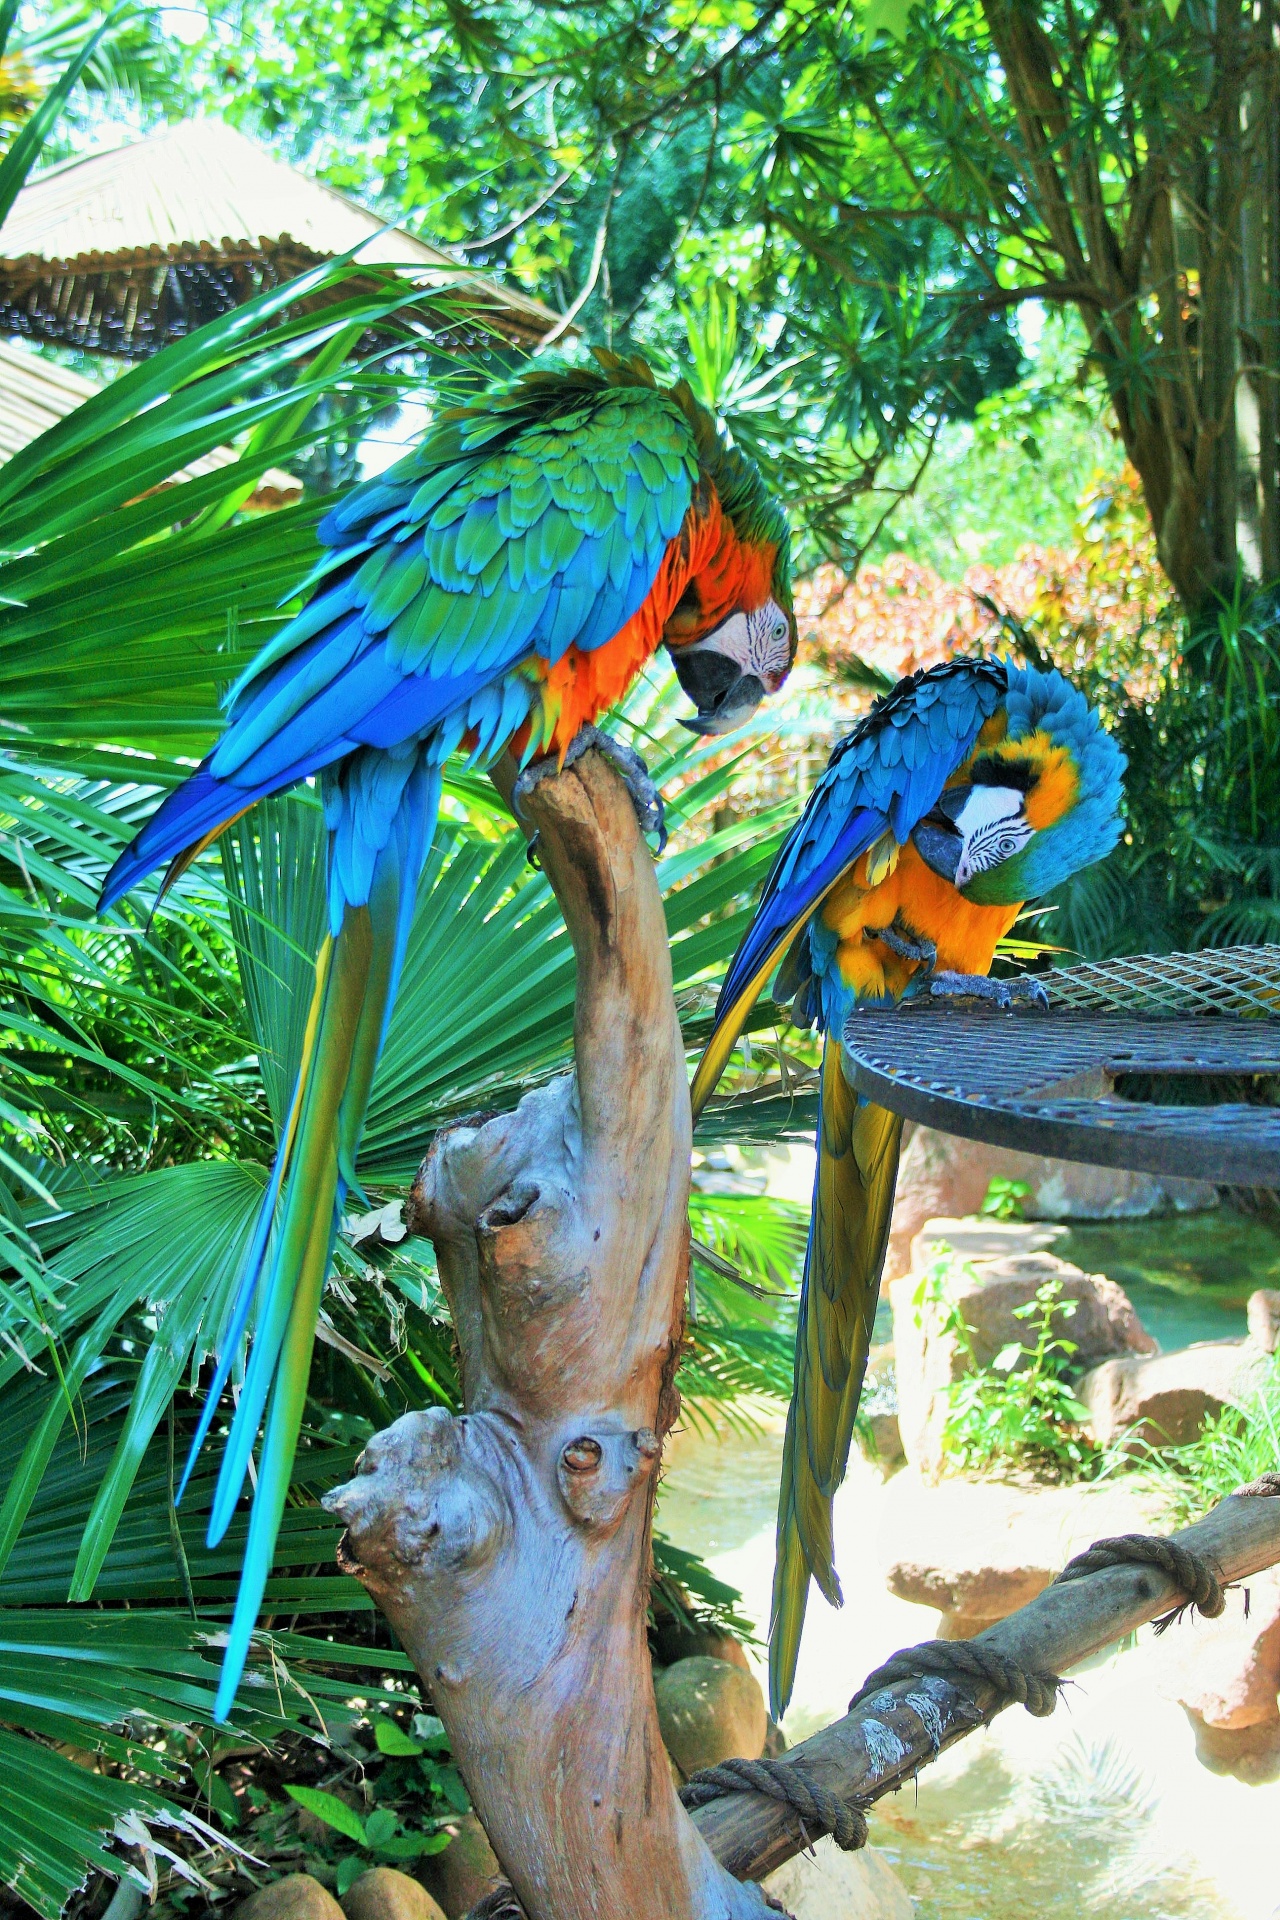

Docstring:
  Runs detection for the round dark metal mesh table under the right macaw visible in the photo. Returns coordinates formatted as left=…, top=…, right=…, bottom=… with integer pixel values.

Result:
left=844, top=947, right=1280, bottom=1187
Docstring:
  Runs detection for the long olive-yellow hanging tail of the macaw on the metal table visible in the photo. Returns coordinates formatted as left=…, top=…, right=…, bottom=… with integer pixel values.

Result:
left=770, top=1039, right=902, bottom=1715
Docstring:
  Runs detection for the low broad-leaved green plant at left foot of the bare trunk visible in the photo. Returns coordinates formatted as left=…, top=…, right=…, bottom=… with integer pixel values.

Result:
left=284, top=1713, right=470, bottom=1899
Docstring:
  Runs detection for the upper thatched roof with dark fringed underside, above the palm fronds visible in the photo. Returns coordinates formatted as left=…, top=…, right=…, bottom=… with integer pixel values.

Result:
left=0, top=121, right=555, bottom=359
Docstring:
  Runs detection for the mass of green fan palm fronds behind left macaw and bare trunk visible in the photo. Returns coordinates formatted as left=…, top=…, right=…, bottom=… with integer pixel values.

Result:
left=0, top=299, right=802, bottom=1920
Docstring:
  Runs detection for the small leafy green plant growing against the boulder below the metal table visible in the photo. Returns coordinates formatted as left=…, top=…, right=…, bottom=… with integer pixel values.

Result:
left=942, top=1281, right=1098, bottom=1478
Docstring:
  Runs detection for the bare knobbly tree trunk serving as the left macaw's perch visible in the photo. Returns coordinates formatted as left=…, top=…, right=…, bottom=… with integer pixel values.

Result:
left=326, top=755, right=768, bottom=1920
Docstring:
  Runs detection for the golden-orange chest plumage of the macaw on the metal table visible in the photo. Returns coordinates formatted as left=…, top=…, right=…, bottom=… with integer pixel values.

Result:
left=821, top=841, right=1021, bottom=998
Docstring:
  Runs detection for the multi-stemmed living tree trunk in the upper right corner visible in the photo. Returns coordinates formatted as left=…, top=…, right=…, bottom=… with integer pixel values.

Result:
left=983, top=0, right=1280, bottom=614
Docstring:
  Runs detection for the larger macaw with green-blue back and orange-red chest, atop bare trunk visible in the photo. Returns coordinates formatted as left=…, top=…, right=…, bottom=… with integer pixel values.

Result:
left=102, top=353, right=796, bottom=1720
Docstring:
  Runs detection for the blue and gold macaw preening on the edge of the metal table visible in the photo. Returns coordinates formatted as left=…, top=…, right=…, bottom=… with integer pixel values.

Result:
left=693, top=660, right=1125, bottom=1715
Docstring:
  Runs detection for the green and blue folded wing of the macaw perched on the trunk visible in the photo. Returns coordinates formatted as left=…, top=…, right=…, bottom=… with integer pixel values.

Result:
left=104, top=390, right=697, bottom=906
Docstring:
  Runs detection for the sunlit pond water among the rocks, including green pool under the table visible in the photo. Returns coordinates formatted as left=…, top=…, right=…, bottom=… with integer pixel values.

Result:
left=658, top=1210, right=1280, bottom=1920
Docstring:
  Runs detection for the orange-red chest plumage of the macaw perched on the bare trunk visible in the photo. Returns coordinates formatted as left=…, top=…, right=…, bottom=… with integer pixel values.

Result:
left=521, top=490, right=773, bottom=755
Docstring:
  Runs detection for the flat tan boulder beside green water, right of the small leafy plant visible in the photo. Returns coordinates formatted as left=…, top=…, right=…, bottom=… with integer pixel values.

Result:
left=1077, top=1340, right=1267, bottom=1446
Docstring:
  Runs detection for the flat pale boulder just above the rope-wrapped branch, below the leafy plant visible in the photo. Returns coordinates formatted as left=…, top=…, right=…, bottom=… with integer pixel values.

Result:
left=877, top=1467, right=1159, bottom=1640
